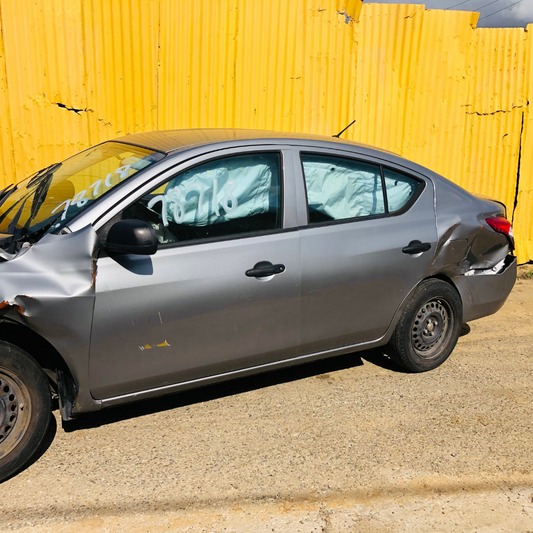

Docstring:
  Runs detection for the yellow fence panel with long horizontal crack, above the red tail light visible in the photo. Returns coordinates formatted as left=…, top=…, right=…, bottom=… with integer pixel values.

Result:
left=461, top=29, right=527, bottom=217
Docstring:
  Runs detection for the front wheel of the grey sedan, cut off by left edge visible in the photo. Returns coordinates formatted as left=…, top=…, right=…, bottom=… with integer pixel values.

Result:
left=0, top=341, right=52, bottom=483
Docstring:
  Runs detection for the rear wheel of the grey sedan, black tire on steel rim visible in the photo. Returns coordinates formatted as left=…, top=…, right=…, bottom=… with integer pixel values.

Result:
left=388, top=279, right=463, bottom=372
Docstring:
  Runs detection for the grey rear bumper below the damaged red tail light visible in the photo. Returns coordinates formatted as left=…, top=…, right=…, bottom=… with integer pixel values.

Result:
left=453, top=255, right=517, bottom=322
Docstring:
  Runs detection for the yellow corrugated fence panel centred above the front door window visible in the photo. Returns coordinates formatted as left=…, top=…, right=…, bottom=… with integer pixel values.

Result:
left=158, top=0, right=239, bottom=129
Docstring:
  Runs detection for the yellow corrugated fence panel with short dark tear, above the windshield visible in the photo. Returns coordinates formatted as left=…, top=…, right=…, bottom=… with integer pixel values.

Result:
left=0, top=0, right=89, bottom=182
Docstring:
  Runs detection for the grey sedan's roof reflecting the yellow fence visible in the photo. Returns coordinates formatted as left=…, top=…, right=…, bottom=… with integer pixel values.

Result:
left=114, top=128, right=397, bottom=155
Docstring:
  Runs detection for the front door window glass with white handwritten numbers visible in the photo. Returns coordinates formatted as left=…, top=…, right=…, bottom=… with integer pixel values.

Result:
left=122, top=153, right=281, bottom=244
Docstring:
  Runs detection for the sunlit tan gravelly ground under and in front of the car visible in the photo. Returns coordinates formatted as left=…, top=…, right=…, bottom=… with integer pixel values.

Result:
left=0, top=280, right=533, bottom=533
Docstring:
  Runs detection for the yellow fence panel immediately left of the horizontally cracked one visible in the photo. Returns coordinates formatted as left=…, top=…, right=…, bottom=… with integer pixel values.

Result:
left=396, top=11, right=473, bottom=187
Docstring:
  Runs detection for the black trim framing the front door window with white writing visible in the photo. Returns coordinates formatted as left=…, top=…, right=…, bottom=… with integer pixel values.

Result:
left=104, top=148, right=286, bottom=251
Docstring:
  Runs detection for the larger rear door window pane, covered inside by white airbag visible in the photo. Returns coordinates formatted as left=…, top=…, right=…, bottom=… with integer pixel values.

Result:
left=302, top=154, right=385, bottom=224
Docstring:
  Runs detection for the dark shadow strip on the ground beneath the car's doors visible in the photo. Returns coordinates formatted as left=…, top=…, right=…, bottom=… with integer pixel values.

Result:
left=63, top=349, right=404, bottom=432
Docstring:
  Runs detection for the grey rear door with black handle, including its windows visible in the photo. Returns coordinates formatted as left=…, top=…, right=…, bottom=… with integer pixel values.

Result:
left=298, top=151, right=437, bottom=353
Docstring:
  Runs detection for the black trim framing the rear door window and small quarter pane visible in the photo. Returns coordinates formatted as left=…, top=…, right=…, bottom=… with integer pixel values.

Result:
left=298, top=150, right=427, bottom=229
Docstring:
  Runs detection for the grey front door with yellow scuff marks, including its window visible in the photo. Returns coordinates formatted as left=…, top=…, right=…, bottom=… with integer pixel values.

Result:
left=90, top=152, right=301, bottom=399
